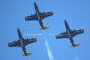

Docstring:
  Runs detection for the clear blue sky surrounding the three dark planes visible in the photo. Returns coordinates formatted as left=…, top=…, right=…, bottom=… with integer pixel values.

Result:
left=0, top=0, right=90, bottom=60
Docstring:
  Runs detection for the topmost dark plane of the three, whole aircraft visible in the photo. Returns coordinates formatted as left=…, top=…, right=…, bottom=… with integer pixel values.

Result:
left=25, top=2, right=53, bottom=30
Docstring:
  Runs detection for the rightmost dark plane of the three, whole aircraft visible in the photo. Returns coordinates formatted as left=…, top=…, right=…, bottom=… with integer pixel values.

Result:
left=56, top=20, right=84, bottom=47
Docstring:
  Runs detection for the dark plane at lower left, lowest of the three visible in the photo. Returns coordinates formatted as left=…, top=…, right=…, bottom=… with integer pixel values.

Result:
left=8, top=29, right=37, bottom=56
